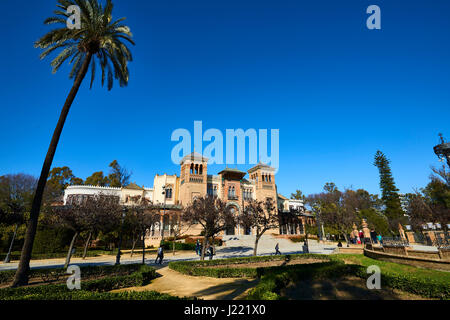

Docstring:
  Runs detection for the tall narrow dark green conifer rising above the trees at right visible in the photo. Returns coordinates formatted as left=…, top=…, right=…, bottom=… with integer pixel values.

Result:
left=374, top=150, right=405, bottom=234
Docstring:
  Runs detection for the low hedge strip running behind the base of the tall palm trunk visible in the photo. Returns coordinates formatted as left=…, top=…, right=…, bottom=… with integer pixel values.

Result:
left=0, top=264, right=147, bottom=284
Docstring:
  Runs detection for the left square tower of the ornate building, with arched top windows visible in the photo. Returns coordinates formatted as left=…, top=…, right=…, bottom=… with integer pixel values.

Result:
left=179, top=152, right=208, bottom=206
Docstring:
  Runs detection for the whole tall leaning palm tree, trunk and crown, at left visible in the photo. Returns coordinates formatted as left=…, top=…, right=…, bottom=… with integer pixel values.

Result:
left=12, top=0, right=134, bottom=287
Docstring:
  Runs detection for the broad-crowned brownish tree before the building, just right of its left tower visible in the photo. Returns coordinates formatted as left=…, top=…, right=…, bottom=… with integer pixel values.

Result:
left=182, top=195, right=236, bottom=260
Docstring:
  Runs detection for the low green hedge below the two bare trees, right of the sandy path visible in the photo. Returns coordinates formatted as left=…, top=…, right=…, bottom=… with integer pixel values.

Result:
left=169, top=254, right=330, bottom=278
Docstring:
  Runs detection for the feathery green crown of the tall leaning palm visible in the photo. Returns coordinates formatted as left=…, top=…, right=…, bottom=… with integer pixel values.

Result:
left=35, top=0, right=135, bottom=90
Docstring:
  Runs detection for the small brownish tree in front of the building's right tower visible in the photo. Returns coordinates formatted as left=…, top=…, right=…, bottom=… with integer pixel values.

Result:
left=239, top=198, right=279, bottom=256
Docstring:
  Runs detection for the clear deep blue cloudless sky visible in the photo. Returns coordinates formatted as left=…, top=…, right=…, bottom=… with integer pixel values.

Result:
left=0, top=0, right=450, bottom=195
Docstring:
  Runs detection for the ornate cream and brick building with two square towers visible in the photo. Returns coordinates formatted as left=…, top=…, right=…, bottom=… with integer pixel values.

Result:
left=64, top=152, right=312, bottom=240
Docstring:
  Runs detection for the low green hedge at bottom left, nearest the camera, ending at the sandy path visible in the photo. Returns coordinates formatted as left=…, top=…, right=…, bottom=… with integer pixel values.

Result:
left=0, top=265, right=161, bottom=300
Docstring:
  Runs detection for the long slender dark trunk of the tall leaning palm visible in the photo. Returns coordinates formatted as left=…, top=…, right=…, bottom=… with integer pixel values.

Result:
left=12, top=52, right=92, bottom=287
